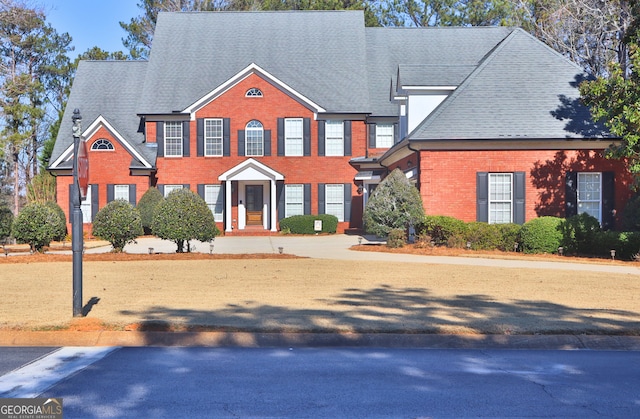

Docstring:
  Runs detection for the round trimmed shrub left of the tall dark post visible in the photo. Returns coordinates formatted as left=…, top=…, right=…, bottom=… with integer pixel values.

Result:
left=12, top=202, right=66, bottom=252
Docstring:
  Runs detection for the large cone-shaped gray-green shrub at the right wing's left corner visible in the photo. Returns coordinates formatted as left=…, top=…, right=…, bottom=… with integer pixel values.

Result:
left=363, top=169, right=424, bottom=237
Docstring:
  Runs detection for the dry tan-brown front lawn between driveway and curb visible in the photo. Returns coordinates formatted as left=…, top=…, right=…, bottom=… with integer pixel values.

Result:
left=0, top=249, right=640, bottom=335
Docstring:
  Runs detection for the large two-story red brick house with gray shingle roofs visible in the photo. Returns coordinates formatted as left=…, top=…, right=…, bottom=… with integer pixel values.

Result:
left=49, top=11, right=630, bottom=234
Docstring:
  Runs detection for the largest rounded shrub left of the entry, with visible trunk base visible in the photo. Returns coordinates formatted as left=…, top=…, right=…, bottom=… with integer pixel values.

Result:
left=151, top=188, right=220, bottom=253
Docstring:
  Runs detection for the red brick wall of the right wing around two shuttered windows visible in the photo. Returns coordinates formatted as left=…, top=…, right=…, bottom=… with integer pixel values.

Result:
left=408, top=150, right=631, bottom=226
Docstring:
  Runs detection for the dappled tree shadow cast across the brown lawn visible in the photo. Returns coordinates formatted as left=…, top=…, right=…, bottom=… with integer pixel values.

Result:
left=120, top=285, right=640, bottom=345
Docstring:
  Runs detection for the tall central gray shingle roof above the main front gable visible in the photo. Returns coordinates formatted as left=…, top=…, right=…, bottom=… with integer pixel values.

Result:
left=139, top=11, right=368, bottom=113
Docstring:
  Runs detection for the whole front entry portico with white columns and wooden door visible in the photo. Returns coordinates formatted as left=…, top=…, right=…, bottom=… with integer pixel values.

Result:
left=218, top=159, right=284, bottom=232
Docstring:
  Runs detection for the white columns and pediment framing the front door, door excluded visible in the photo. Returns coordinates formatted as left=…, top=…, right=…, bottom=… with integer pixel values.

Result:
left=218, top=159, right=284, bottom=231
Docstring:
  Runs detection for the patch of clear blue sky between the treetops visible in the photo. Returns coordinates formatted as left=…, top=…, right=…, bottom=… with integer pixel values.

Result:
left=38, top=0, right=142, bottom=59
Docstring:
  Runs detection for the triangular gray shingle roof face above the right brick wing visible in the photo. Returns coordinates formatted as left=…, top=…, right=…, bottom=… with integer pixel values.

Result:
left=410, top=29, right=605, bottom=140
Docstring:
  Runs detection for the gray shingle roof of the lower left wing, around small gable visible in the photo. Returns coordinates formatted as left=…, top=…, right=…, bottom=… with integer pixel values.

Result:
left=51, top=61, right=155, bottom=166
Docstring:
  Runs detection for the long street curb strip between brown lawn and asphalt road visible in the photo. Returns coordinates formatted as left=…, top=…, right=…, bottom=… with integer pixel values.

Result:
left=0, top=331, right=640, bottom=351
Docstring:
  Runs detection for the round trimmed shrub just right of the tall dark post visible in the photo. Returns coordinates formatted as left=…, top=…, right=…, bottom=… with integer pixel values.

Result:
left=92, top=199, right=143, bottom=252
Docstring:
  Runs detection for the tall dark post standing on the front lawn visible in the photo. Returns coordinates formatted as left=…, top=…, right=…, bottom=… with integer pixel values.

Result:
left=71, top=109, right=86, bottom=317
